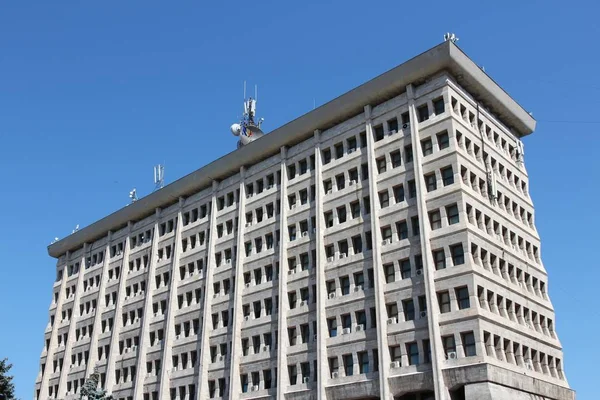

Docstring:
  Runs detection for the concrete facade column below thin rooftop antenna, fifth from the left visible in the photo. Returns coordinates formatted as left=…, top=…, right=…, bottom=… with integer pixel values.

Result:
left=133, top=210, right=163, bottom=400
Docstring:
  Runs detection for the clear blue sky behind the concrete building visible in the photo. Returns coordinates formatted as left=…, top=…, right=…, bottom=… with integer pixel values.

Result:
left=0, top=0, right=600, bottom=400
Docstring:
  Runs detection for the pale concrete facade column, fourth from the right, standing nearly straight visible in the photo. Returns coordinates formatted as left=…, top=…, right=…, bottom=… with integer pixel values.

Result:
left=277, top=147, right=290, bottom=399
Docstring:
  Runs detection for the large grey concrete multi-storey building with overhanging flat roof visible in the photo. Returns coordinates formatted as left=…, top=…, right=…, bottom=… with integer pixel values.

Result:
left=35, top=41, right=574, bottom=400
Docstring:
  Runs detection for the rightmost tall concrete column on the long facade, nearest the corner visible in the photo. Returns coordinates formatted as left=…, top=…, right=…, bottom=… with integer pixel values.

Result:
left=406, top=84, right=449, bottom=400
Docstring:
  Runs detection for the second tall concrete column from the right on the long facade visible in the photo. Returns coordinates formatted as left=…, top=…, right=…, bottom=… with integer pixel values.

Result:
left=365, top=105, right=393, bottom=400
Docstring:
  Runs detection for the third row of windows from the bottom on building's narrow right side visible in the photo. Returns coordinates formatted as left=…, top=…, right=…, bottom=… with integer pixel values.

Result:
left=471, top=243, right=548, bottom=299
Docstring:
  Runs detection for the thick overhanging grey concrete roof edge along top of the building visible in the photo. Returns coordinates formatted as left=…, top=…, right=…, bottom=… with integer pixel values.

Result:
left=48, top=41, right=535, bottom=258
